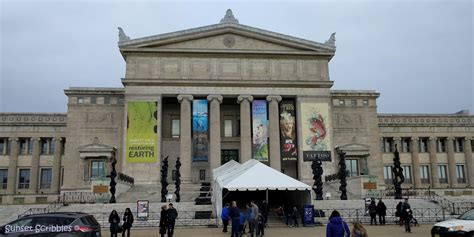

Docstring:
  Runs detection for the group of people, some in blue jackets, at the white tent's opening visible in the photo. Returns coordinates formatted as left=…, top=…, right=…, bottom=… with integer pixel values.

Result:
left=221, top=201, right=268, bottom=237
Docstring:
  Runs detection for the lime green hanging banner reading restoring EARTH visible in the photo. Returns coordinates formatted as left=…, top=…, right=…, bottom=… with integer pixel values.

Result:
left=126, top=101, right=158, bottom=163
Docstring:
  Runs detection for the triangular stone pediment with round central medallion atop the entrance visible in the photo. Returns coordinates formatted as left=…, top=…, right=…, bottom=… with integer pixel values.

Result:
left=119, top=23, right=336, bottom=57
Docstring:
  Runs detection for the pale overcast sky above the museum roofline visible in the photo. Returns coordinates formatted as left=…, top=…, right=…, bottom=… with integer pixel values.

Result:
left=0, top=0, right=474, bottom=114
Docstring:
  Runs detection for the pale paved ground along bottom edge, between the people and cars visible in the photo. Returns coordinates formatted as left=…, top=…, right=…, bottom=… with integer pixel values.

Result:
left=102, top=225, right=432, bottom=237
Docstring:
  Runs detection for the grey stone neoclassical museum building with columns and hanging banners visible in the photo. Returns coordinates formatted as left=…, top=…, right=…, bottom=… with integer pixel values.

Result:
left=0, top=10, right=474, bottom=204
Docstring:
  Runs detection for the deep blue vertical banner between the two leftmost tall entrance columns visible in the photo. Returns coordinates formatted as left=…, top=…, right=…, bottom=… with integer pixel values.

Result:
left=193, top=100, right=209, bottom=161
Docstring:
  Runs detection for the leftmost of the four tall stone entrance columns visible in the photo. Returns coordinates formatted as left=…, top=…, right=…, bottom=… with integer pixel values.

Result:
left=178, top=95, right=194, bottom=183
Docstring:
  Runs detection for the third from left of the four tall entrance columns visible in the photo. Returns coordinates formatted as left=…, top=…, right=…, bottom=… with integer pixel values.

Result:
left=237, top=95, right=253, bottom=163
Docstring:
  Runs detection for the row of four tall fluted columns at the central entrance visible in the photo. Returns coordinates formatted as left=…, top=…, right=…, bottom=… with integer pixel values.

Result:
left=178, top=95, right=282, bottom=182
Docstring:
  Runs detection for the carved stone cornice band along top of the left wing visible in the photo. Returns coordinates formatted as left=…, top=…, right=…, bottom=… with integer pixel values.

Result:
left=0, top=113, right=67, bottom=126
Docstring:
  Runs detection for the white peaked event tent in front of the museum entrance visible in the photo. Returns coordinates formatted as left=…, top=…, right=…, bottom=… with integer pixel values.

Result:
left=212, top=159, right=312, bottom=216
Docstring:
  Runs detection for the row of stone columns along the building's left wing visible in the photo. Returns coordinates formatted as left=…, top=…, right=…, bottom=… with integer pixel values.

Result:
left=7, top=137, right=63, bottom=194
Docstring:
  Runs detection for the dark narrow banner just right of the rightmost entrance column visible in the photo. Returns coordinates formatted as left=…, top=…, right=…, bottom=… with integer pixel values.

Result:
left=280, top=101, right=298, bottom=161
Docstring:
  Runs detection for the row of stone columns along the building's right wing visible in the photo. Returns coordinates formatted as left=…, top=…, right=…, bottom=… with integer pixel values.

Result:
left=395, top=137, right=474, bottom=188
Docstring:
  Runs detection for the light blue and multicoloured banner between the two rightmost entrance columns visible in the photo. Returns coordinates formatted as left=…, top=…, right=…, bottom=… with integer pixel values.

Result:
left=252, top=100, right=268, bottom=161
